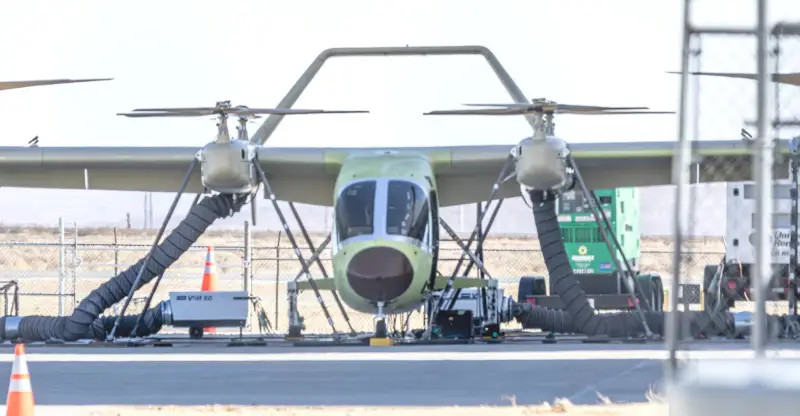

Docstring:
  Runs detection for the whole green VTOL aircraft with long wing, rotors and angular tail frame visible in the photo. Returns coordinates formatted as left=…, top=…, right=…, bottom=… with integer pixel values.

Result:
left=0, top=46, right=787, bottom=338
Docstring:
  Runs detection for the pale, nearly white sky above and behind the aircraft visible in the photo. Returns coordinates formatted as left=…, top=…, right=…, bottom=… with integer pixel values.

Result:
left=0, top=0, right=800, bottom=232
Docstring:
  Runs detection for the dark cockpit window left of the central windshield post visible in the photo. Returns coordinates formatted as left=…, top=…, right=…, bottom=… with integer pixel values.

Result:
left=336, top=181, right=375, bottom=241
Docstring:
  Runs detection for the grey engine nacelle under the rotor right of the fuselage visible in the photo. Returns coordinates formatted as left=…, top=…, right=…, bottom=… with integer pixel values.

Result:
left=516, top=137, right=575, bottom=192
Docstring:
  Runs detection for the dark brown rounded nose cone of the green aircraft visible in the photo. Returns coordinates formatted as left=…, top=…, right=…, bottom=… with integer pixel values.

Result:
left=347, top=247, right=414, bottom=302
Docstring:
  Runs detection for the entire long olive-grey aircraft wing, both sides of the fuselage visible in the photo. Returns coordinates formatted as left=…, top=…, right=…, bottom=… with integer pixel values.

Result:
left=0, top=140, right=789, bottom=206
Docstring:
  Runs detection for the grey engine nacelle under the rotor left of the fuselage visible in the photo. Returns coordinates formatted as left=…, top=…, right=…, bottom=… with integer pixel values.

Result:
left=199, top=140, right=258, bottom=194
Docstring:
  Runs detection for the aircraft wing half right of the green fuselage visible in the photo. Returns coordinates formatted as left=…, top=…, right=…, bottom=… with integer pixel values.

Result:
left=428, top=140, right=790, bottom=206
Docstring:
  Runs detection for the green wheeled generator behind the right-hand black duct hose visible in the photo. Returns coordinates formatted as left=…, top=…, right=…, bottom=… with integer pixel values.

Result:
left=518, top=188, right=664, bottom=310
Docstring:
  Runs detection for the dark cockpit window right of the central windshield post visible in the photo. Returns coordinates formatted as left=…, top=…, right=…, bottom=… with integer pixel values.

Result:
left=386, top=180, right=429, bottom=241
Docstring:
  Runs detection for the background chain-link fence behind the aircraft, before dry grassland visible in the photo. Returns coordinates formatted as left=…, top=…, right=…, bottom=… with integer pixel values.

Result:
left=0, top=224, right=723, bottom=333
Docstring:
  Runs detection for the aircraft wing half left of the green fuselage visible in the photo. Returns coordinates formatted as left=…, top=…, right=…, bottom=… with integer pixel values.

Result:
left=0, top=147, right=338, bottom=205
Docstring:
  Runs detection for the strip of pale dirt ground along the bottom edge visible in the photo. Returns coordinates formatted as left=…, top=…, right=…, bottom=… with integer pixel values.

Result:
left=23, top=402, right=667, bottom=416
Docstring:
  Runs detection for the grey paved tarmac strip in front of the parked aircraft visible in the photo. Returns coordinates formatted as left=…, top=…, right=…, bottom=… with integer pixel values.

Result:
left=0, top=342, right=800, bottom=406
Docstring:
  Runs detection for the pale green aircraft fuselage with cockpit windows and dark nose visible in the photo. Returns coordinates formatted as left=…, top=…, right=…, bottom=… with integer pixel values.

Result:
left=332, top=153, right=438, bottom=314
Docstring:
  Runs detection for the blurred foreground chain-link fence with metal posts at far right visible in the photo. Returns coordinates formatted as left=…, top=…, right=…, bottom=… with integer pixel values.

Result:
left=667, top=0, right=800, bottom=378
